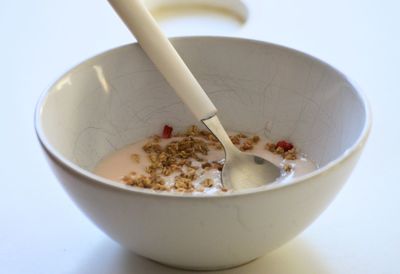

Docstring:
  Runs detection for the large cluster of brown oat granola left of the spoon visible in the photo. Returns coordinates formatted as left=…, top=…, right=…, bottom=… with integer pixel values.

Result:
left=122, top=126, right=225, bottom=192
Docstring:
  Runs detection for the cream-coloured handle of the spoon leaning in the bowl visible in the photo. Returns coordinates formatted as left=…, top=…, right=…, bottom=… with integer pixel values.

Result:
left=108, top=0, right=217, bottom=120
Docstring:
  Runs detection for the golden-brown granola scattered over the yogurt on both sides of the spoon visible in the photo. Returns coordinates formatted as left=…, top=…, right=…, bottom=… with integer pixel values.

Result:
left=94, top=125, right=314, bottom=193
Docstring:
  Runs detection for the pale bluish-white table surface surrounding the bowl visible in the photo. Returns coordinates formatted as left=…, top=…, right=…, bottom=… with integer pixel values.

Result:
left=0, top=0, right=400, bottom=274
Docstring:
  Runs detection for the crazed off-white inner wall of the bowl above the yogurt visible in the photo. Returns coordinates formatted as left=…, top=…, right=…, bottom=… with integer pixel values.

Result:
left=38, top=37, right=366, bottom=176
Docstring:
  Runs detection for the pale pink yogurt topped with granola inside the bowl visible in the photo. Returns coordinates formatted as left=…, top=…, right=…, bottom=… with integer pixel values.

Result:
left=94, top=128, right=316, bottom=194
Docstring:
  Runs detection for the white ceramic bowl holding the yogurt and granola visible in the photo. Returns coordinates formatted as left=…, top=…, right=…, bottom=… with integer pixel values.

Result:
left=36, top=37, right=370, bottom=269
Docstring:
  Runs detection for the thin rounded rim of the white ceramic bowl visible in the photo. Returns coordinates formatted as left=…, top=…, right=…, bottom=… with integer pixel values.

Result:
left=34, top=36, right=372, bottom=199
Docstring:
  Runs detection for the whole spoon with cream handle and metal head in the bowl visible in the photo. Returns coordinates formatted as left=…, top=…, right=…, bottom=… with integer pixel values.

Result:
left=108, top=0, right=280, bottom=190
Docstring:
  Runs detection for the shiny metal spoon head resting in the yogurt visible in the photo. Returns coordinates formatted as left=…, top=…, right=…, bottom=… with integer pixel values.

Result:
left=222, top=153, right=280, bottom=190
